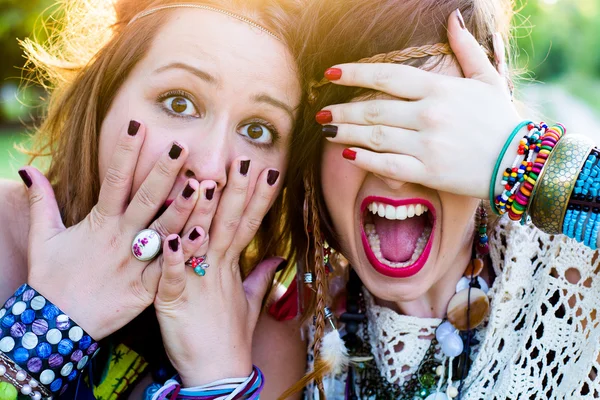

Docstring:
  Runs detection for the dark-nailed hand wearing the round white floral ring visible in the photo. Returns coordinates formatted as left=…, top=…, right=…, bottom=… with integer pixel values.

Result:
left=20, top=122, right=205, bottom=340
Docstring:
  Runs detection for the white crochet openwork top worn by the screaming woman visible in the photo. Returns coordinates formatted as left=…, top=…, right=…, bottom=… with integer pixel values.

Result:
left=305, top=218, right=600, bottom=400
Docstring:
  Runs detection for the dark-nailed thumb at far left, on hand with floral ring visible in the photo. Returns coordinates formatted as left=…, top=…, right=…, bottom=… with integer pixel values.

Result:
left=19, top=167, right=65, bottom=241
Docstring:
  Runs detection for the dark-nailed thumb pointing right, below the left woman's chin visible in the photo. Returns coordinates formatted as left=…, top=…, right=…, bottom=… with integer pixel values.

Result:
left=244, top=257, right=287, bottom=322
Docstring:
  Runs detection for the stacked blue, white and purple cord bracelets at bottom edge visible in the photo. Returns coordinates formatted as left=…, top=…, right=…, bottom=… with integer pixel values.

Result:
left=152, top=366, right=265, bottom=400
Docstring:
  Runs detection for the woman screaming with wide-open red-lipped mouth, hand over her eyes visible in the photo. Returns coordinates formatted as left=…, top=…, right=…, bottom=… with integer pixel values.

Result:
left=283, top=0, right=600, bottom=400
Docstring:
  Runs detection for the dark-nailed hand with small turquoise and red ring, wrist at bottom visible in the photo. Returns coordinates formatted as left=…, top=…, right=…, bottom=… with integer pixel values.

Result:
left=154, top=158, right=284, bottom=387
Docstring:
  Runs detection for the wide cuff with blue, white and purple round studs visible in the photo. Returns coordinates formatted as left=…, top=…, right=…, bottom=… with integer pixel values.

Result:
left=0, top=284, right=100, bottom=394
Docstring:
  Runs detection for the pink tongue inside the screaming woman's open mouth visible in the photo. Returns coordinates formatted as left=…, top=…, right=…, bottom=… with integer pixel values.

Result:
left=374, top=215, right=426, bottom=262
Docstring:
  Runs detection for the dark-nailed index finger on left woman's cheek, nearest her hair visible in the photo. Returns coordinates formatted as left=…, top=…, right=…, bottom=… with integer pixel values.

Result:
left=96, top=120, right=146, bottom=217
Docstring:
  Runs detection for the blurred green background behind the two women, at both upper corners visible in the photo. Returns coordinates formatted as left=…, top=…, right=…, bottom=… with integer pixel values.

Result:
left=0, top=0, right=600, bottom=179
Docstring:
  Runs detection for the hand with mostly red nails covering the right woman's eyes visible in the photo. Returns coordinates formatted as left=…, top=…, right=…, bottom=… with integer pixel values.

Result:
left=320, top=12, right=521, bottom=198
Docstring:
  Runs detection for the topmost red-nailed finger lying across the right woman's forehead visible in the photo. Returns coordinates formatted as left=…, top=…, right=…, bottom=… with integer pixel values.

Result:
left=325, top=63, right=447, bottom=100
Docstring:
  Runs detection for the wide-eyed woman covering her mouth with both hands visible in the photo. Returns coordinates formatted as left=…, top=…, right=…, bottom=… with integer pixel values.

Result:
left=0, top=0, right=303, bottom=399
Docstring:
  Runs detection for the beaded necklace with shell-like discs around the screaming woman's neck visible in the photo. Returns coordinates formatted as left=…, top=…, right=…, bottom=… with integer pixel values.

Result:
left=340, top=207, right=489, bottom=400
